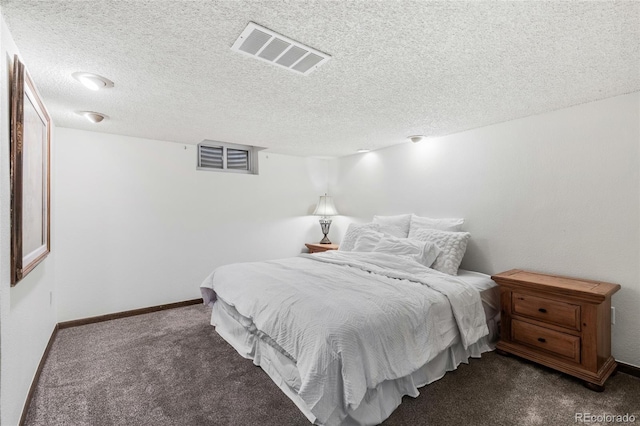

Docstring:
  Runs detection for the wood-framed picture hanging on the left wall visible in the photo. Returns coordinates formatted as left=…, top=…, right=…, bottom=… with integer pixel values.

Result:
left=10, top=55, right=51, bottom=286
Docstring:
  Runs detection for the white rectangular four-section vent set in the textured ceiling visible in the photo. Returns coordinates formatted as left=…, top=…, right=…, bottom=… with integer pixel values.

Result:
left=231, top=22, right=331, bottom=75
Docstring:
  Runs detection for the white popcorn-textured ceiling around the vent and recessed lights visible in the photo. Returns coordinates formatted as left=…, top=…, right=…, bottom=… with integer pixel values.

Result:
left=1, top=0, right=640, bottom=156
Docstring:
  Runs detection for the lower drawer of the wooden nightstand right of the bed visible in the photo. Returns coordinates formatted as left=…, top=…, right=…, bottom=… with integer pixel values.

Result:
left=511, top=319, right=580, bottom=363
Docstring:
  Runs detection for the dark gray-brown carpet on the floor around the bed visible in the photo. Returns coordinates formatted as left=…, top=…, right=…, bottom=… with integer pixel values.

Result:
left=26, top=305, right=640, bottom=426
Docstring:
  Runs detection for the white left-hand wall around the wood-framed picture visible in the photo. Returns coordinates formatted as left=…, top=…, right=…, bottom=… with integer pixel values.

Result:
left=0, top=13, right=57, bottom=425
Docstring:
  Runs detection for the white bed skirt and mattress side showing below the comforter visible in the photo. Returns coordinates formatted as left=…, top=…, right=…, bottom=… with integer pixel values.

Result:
left=211, top=270, right=499, bottom=425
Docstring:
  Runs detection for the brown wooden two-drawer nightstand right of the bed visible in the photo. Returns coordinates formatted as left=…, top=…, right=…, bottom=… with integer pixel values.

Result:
left=491, top=269, right=620, bottom=392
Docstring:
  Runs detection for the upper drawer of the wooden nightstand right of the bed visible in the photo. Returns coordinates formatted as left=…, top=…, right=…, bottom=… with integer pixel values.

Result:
left=511, top=292, right=580, bottom=331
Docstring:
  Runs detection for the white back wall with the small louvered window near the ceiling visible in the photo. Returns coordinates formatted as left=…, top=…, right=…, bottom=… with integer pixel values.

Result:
left=54, top=128, right=328, bottom=321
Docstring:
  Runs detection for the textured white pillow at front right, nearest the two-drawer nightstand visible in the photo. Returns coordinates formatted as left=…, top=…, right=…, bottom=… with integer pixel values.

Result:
left=412, top=229, right=471, bottom=275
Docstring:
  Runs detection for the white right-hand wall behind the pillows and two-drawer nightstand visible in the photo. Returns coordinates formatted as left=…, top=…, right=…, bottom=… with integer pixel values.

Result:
left=329, top=93, right=640, bottom=366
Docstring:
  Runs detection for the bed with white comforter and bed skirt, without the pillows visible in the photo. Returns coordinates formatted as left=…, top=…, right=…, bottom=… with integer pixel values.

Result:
left=201, top=248, right=499, bottom=425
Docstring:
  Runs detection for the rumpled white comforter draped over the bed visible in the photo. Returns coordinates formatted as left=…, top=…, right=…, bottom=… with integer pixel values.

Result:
left=201, top=251, right=488, bottom=424
